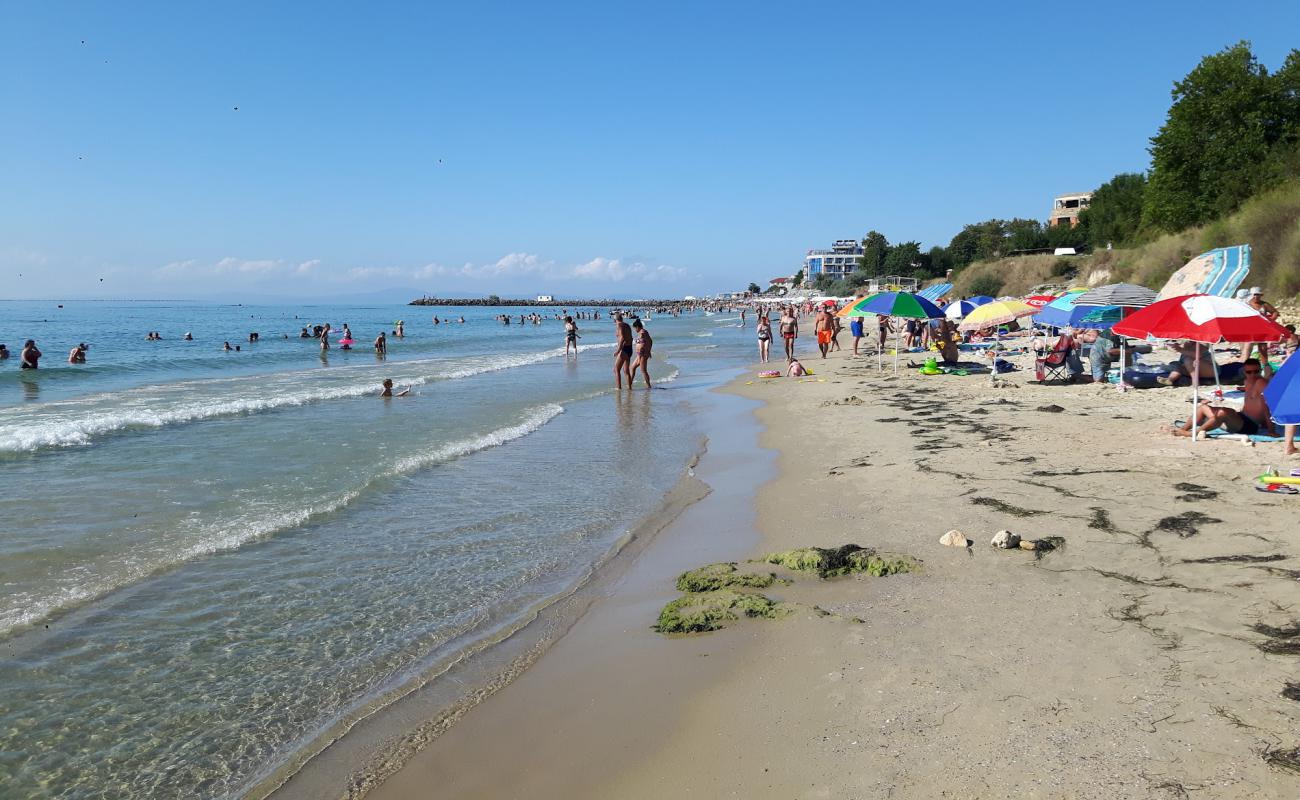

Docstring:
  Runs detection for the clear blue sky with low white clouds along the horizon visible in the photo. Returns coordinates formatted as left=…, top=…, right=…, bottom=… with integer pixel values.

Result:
left=0, top=0, right=1300, bottom=299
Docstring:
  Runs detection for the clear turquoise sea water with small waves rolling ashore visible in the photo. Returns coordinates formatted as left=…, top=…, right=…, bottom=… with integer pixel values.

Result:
left=0, top=302, right=753, bottom=799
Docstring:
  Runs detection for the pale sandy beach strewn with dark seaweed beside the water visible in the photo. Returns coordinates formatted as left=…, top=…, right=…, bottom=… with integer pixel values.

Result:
left=356, top=354, right=1300, bottom=800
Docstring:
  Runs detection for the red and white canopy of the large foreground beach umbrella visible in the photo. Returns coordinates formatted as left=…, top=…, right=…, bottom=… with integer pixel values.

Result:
left=1113, top=294, right=1291, bottom=345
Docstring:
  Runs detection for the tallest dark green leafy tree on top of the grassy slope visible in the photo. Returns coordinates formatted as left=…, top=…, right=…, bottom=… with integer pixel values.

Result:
left=1143, top=42, right=1300, bottom=230
